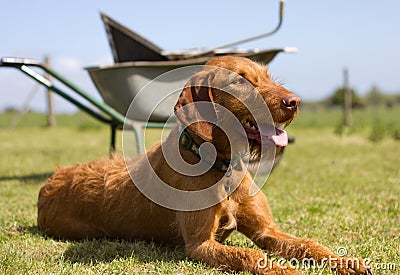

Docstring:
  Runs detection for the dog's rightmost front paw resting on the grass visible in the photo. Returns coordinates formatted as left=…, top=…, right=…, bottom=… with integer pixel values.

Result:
left=331, top=257, right=373, bottom=275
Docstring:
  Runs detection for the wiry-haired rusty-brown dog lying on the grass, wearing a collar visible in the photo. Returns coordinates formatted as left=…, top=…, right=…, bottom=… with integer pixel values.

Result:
left=38, top=57, right=372, bottom=274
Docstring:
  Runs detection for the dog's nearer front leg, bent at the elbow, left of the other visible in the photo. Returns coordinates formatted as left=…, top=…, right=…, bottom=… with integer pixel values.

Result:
left=178, top=207, right=301, bottom=275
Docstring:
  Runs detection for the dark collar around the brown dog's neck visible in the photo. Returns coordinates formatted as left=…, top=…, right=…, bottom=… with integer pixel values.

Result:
left=179, top=127, right=240, bottom=176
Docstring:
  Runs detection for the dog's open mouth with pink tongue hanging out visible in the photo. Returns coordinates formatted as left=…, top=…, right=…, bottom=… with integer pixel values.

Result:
left=242, top=119, right=288, bottom=147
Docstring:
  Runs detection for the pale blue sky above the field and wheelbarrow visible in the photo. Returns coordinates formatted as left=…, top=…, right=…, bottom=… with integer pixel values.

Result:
left=0, top=0, right=400, bottom=112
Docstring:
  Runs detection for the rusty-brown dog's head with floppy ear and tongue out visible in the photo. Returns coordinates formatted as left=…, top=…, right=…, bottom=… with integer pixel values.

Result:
left=175, top=56, right=300, bottom=162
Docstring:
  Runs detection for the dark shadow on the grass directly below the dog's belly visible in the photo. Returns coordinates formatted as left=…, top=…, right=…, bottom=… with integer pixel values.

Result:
left=63, top=239, right=186, bottom=264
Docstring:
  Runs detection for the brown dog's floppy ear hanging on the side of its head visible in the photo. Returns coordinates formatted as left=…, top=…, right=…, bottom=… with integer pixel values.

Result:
left=174, top=70, right=217, bottom=141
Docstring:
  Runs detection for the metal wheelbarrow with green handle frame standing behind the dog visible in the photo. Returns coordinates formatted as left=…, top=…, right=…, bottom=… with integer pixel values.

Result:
left=0, top=0, right=294, bottom=168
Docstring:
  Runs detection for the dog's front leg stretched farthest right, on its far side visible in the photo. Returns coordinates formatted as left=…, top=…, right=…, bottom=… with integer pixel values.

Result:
left=237, top=192, right=372, bottom=275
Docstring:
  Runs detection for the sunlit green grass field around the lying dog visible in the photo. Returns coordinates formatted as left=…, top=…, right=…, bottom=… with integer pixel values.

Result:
left=0, top=109, right=400, bottom=274
